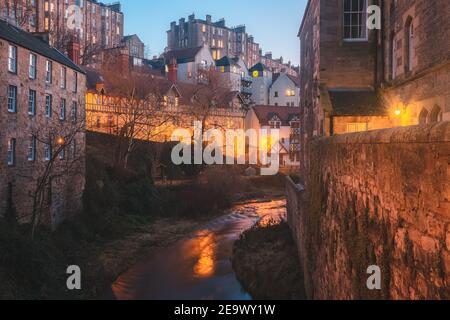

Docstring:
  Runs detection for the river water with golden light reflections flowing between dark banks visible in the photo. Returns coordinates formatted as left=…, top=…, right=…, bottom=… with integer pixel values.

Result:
left=107, top=200, right=286, bottom=300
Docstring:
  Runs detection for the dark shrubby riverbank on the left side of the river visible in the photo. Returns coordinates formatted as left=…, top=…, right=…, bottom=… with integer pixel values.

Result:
left=0, top=132, right=281, bottom=299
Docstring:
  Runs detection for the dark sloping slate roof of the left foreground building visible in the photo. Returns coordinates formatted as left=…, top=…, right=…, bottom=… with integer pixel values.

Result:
left=0, top=19, right=85, bottom=73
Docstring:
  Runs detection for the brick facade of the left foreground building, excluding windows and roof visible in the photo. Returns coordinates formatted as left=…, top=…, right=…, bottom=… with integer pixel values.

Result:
left=0, top=39, right=86, bottom=225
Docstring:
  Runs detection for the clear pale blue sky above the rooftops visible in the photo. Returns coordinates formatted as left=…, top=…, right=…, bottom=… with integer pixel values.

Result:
left=120, top=0, right=307, bottom=65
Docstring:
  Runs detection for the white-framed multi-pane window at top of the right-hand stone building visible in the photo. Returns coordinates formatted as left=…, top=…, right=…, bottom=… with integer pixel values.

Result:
left=343, top=0, right=367, bottom=40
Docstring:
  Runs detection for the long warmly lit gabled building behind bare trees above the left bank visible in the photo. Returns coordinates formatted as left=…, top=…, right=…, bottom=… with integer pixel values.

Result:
left=86, top=69, right=247, bottom=142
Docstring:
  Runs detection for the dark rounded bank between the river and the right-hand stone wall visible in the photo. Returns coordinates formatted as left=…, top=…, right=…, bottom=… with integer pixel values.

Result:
left=232, top=221, right=306, bottom=300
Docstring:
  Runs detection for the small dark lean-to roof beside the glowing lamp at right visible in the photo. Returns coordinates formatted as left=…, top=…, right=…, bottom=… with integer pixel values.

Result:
left=328, top=90, right=387, bottom=116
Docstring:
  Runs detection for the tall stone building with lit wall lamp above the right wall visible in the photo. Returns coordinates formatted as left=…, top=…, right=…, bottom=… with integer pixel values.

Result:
left=299, top=0, right=450, bottom=144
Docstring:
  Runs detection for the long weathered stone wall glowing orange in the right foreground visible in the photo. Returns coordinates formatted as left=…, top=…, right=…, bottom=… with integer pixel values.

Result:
left=287, top=122, right=450, bottom=299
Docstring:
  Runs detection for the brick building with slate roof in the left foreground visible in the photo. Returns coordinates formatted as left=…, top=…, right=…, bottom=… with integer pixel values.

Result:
left=0, top=20, right=86, bottom=226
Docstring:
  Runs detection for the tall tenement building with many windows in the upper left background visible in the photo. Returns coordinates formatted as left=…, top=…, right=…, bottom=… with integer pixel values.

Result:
left=0, top=0, right=124, bottom=61
